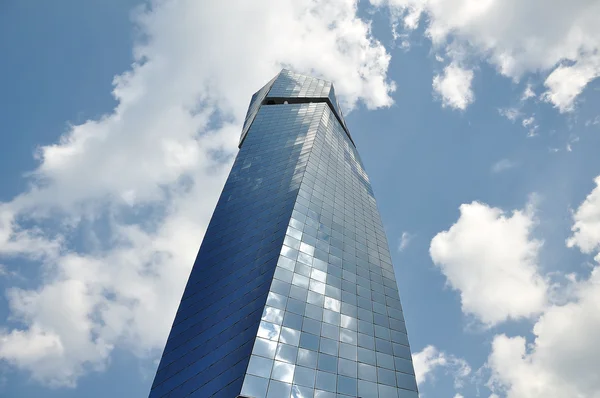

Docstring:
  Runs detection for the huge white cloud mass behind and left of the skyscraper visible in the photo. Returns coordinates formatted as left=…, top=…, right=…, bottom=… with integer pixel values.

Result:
left=0, top=0, right=394, bottom=386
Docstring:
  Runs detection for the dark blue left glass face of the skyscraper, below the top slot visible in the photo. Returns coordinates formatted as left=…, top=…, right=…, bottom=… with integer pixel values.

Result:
left=150, top=104, right=327, bottom=398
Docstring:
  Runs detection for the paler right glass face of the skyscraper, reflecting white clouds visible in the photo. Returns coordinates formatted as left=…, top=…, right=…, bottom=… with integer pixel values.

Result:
left=242, top=102, right=418, bottom=398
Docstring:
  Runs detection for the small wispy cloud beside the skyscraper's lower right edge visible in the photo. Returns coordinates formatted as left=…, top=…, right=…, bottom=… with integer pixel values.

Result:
left=412, top=345, right=471, bottom=388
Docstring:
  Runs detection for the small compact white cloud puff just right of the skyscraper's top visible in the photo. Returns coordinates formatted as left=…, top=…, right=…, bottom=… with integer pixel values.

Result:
left=433, top=63, right=474, bottom=110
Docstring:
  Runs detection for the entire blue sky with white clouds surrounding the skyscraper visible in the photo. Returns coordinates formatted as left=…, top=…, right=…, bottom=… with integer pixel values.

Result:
left=0, top=0, right=600, bottom=398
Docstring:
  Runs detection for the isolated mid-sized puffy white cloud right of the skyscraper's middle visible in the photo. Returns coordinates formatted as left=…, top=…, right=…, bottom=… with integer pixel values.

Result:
left=429, top=198, right=548, bottom=326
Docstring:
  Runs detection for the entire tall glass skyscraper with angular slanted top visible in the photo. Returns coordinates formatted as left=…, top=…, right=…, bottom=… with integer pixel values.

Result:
left=150, top=69, right=418, bottom=398
